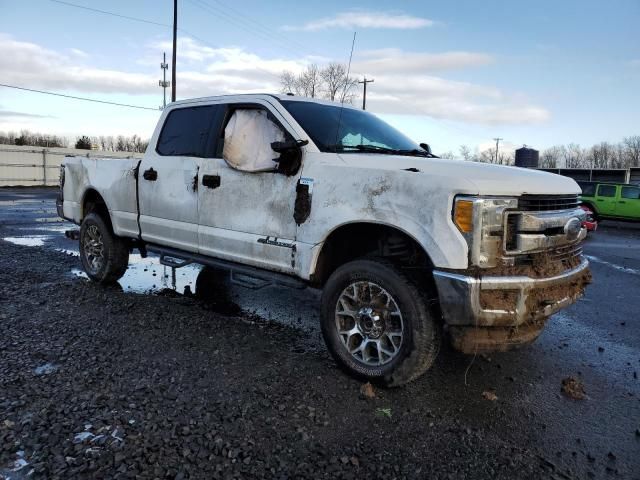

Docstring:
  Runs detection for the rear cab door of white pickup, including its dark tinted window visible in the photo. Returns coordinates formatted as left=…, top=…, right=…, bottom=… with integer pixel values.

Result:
left=138, top=105, right=218, bottom=252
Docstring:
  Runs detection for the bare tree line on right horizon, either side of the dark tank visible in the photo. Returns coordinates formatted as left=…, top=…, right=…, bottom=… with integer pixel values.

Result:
left=439, top=135, right=640, bottom=168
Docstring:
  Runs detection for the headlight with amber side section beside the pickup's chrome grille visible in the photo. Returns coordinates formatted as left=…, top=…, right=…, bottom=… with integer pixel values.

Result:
left=453, top=196, right=518, bottom=268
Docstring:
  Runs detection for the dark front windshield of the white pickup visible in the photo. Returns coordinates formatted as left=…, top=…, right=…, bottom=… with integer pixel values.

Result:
left=280, top=100, right=424, bottom=153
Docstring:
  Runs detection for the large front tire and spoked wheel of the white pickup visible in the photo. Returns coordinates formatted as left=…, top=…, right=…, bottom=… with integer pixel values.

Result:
left=320, top=259, right=441, bottom=387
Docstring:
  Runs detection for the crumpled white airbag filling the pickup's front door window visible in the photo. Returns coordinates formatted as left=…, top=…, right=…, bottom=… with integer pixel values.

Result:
left=222, top=109, right=284, bottom=172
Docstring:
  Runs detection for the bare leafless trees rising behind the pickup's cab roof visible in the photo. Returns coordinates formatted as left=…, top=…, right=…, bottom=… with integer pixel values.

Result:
left=280, top=62, right=358, bottom=103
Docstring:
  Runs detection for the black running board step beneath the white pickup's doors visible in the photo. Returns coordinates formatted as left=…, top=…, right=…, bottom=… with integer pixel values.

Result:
left=146, top=244, right=307, bottom=290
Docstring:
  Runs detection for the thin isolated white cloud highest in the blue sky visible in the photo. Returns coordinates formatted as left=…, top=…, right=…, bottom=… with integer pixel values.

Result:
left=284, top=10, right=435, bottom=32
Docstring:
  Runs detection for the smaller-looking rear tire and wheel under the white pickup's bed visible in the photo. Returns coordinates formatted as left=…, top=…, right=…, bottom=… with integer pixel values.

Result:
left=79, top=213, right=129, bottom=284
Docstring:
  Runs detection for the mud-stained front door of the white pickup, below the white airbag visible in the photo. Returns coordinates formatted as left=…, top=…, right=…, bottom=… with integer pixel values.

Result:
left=198, top=101, right=301, bottom=273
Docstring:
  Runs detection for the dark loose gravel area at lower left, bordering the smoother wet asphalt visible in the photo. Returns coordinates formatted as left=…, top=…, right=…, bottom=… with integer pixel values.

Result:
left=0, top=241, right=554, bottom=479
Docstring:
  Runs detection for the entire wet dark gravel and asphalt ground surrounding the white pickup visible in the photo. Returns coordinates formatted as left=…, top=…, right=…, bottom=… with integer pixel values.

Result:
left=0, top=189, right=640, bottom=480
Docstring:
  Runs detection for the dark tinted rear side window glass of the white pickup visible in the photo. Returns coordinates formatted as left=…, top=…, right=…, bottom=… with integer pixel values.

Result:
left=156, top=105, right=222, bottom=158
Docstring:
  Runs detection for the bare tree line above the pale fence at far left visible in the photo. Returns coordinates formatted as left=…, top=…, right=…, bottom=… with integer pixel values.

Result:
left=0, top=130, right=149, bottom=153
